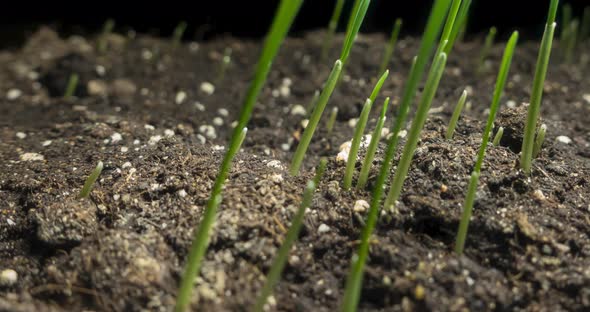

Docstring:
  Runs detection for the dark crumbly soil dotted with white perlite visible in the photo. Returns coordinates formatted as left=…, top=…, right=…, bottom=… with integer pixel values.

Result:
left=0, top=29, right=590, bottom=311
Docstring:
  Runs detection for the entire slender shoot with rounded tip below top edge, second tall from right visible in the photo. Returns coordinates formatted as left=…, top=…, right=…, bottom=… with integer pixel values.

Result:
left=455, top=31, right=518, bottom=255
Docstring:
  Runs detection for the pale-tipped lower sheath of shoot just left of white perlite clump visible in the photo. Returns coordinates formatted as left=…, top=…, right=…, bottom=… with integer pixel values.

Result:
left=289, top=60, right=342, bottom=176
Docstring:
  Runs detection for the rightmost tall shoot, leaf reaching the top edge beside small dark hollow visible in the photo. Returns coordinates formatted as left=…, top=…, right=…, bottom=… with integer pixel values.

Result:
left=520, top=0, right=559, bottom=175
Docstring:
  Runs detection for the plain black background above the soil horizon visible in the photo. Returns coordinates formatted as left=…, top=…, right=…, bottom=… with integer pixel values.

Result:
left=0, top=0, right=590, bottom=47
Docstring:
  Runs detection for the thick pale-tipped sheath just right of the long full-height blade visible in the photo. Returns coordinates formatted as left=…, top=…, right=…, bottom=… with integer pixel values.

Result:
left=384, top=52, right=447, bottom=210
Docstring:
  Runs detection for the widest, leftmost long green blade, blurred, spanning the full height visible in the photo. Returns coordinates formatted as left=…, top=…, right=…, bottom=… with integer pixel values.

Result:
left=175, top=0, right=303, bottom=312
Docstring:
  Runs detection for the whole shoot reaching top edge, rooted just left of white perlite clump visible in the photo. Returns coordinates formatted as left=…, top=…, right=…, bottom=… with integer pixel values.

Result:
left=289, top=0, right=371, bottom=176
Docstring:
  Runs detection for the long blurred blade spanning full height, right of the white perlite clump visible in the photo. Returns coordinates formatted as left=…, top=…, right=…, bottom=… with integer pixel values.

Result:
left=340, top=0, right=451, bottom=312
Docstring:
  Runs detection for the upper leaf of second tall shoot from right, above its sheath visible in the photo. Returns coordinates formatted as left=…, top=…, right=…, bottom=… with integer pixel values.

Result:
left=473, top=31, right=518, bottom=172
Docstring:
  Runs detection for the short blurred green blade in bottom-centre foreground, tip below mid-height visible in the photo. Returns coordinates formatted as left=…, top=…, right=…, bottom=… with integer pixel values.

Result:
left=252, top=181, right=316, bottom=312
